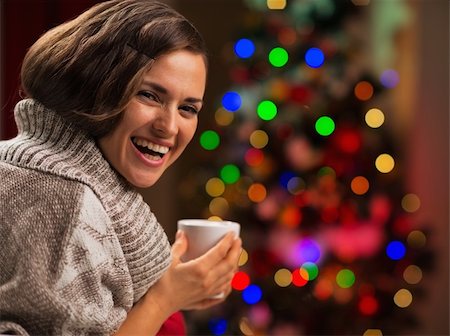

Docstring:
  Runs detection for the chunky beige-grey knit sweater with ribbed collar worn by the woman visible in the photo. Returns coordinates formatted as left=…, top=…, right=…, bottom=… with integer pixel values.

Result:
left=0, top=99, right=170, bottom=336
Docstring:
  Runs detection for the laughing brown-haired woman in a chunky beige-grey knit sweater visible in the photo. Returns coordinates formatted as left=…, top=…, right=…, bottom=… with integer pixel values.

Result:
left=0, top=0, right=241, bottom=335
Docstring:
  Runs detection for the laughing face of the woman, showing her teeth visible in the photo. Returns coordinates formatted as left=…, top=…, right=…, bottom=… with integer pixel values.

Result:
left=99, top=50, right=206, bottom=188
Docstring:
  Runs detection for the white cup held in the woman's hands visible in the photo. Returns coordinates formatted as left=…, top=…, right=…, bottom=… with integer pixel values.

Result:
left=178, top=219, right=241, bottom=261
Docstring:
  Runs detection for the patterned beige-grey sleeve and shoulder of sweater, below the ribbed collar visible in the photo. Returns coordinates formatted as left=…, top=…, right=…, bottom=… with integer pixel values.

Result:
left=0, top=169, right=133, bottom=335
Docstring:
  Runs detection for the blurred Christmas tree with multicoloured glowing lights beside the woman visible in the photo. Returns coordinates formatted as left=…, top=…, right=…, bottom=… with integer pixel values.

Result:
left=180, top=0, right=432, bottom=335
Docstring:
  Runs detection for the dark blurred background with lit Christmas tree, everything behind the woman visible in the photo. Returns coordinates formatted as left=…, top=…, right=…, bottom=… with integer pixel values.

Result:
left=0, top=0, right=449, bottom=336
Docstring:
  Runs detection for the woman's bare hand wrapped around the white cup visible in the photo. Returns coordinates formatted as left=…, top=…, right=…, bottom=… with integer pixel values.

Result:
left=144, top=231, right=241, bottom=315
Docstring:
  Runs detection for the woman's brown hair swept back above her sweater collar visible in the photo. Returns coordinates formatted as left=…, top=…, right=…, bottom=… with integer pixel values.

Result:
left=21, top=0, right=207, bottom=137
